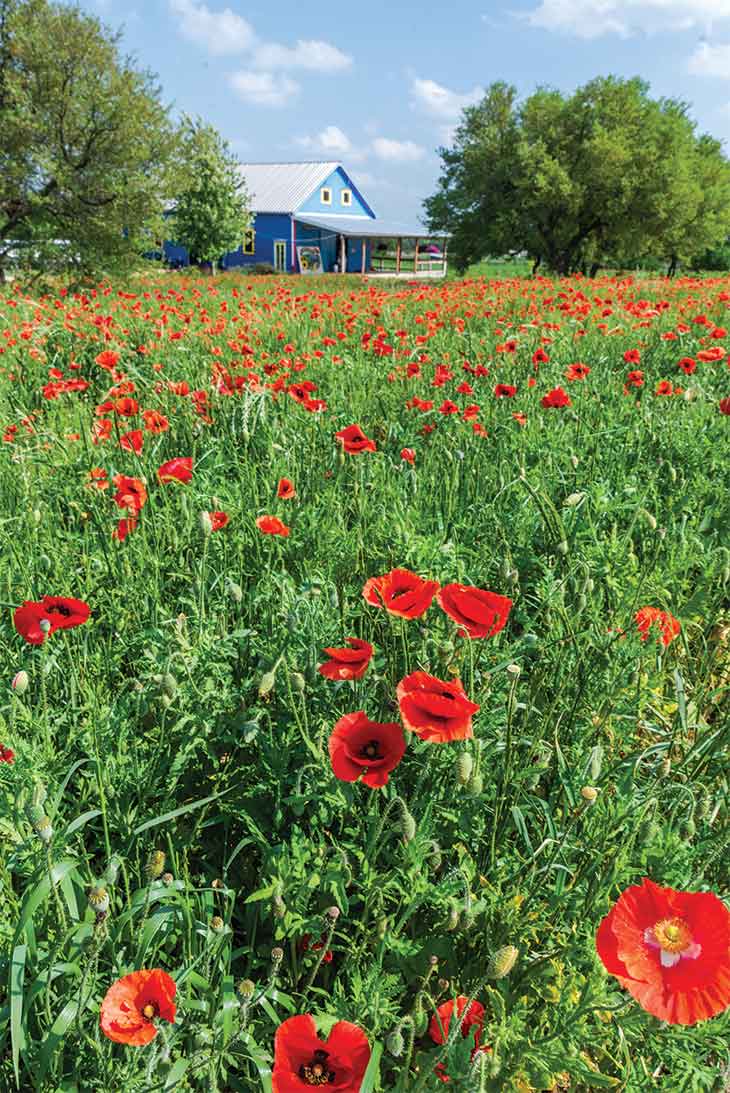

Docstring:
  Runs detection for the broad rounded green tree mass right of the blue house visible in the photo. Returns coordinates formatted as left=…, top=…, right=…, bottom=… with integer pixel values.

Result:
left=425, top=77, right=730, bottom=274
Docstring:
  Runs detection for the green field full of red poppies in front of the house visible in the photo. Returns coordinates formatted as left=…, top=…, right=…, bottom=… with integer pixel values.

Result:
left=0, top=266, right=730, bottom=1093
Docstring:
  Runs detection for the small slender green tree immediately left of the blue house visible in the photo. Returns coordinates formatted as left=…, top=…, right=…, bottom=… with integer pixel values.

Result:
left=172, top=117, right=250, bottom=270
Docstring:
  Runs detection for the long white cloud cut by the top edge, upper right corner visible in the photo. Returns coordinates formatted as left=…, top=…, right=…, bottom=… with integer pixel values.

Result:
left=527, top=0, right=730, bottom=38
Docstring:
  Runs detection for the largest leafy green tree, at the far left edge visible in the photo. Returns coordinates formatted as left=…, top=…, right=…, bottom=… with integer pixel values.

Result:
left=0, top=0, right=176, bottom=275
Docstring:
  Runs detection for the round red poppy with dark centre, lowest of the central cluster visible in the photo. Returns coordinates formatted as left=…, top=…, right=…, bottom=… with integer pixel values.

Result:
left=329, top=709, right=405, bottom=789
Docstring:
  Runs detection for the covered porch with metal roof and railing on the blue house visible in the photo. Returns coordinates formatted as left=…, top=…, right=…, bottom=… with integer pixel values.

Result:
left=294, top=214, right=448, bottom=279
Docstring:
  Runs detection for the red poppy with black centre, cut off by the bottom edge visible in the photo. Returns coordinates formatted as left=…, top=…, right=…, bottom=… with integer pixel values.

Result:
left=271, top=1013, right=370, bottom=1093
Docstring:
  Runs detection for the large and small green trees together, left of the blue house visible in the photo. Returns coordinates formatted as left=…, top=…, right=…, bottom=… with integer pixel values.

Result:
left=0, top=0, right=249, bottom=279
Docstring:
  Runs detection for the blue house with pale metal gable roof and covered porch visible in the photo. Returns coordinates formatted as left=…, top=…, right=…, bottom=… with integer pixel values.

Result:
left=164, top=161, right=446, bottom=277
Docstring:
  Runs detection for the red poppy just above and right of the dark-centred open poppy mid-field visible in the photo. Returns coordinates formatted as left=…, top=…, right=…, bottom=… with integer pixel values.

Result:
left=396, top=672, right=480, bottom=744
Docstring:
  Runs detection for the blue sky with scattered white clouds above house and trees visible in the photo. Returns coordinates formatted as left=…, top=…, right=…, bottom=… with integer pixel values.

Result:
left=82, top=0, right=730, bottom=221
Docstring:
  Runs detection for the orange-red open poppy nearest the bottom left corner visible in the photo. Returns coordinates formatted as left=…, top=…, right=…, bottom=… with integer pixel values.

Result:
left=101, top=967, right=177, bottom=1047
